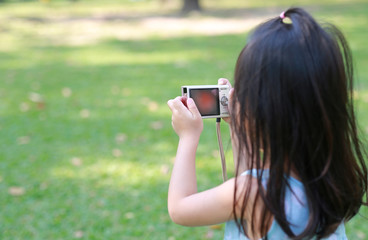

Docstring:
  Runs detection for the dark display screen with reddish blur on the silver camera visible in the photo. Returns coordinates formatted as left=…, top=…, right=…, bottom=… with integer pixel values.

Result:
left=190, top=88, right=220, bottom=116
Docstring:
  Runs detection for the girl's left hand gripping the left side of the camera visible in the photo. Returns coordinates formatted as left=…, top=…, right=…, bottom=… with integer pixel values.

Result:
left=167, top=97, right=203, bottom=139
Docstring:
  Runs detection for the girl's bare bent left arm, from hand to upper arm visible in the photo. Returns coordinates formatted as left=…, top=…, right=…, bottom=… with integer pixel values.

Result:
left=168, top=97, right=234, bottom=226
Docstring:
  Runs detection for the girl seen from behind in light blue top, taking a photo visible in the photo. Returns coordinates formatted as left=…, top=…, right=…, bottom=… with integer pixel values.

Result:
left=168, top=8, right=367, bottom=240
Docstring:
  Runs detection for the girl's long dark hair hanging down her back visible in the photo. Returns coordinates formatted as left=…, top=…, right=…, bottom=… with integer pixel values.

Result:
left=232, top=8, right=367, bottom=239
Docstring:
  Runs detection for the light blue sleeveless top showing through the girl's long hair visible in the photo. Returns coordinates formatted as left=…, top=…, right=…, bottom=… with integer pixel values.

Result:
left=224, top=169, right=347, bottom=240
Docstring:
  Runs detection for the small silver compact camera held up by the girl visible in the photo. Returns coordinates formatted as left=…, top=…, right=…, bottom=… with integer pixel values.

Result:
left=181, top=85, right=230, bottom=118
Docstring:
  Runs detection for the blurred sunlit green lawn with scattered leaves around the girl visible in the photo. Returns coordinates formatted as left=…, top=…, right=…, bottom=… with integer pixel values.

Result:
left=0, top=0, right=368, bottom=240
